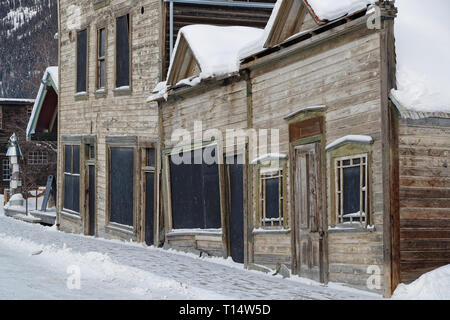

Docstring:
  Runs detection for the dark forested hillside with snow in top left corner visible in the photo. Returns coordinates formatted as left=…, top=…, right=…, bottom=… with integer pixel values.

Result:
left=0, top=0, right=58, bottom=98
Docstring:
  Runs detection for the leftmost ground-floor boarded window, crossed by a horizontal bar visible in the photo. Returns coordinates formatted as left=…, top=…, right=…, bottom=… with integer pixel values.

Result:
left=64, top=145, right=80, bottom=212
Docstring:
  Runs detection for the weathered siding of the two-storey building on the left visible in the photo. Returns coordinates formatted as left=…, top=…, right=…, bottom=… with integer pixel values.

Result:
left=57, top=0, right=161, bottom=240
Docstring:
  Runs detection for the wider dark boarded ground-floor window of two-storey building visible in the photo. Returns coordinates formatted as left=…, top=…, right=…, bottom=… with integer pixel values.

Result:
left=109, top=147, right=134, bottom=226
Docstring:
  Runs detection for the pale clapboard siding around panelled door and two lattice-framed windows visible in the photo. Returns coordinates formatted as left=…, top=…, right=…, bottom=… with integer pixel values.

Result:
left=251, top=22, right=384, bottom=288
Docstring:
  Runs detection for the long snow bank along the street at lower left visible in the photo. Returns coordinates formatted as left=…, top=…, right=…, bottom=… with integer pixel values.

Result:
left=0, top=233, right=229, bottom=300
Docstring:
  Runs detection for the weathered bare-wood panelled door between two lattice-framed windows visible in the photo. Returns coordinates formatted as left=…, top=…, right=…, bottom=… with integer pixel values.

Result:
left=293, top=143, right=324, bottom=282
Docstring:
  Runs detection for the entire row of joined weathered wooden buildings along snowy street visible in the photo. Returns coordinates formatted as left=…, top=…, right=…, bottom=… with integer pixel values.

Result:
left=57, top=0, right=450, bottom=296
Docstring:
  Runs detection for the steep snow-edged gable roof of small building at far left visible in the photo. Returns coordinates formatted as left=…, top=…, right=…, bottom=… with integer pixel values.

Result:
left=26, top=67, right=59, bottom=139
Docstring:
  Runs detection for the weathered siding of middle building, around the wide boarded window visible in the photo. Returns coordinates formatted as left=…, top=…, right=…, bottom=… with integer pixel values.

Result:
left=160, top=81, right=247, bottom=256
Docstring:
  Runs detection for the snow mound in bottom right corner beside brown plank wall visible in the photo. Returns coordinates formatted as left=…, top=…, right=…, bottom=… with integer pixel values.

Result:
left=392, top=265, right=450, bottom=300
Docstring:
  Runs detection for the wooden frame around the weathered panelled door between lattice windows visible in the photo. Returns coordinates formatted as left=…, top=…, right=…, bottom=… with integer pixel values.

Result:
left=289, top=134, right=328, bottom=283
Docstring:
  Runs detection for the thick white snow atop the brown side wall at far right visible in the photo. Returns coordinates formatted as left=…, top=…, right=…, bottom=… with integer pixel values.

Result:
left=390, top=0, right=450, bottom=119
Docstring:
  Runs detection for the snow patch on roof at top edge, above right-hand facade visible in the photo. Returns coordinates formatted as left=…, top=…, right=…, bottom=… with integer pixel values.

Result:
left=306, top=0, right=377, bottom=21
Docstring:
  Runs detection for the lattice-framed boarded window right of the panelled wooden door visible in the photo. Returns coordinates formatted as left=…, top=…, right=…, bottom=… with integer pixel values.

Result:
left=335, top=155, right=368, bottom=224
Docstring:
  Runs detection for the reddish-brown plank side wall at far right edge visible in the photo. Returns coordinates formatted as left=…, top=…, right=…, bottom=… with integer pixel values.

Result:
left=399, top=119, right=450, bottom=283
